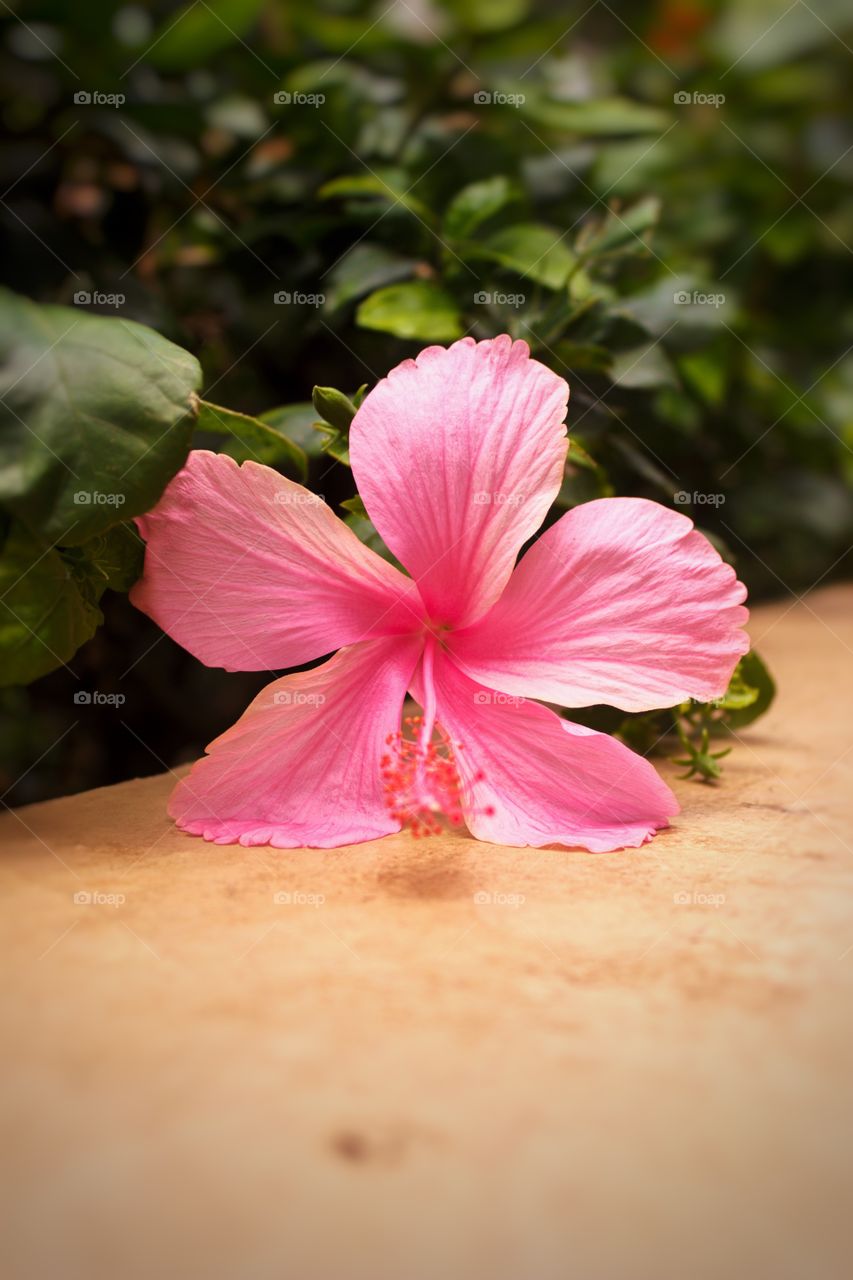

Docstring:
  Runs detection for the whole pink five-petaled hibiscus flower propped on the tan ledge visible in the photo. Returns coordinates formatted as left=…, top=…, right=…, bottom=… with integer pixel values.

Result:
left=132, top=335, right=748, bottom=851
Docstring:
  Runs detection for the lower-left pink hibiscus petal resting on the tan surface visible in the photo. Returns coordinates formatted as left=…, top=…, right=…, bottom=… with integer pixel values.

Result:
left=169, top=636, right=420, bottom=849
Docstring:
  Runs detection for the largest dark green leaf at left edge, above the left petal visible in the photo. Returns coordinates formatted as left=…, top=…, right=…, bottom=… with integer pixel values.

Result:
left=0, top=291, right=201, bottom=545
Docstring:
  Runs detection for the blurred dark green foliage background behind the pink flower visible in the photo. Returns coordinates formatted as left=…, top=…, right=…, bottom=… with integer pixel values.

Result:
left=0, top=0, right=853, bottom=804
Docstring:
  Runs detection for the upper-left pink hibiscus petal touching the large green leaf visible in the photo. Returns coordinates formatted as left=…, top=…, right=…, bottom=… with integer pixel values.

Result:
left=131, top=449, right=423, bottom=671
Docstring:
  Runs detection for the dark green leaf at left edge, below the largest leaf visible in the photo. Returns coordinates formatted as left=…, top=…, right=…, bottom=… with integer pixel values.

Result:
left=0, top=524, right=104, bottom=686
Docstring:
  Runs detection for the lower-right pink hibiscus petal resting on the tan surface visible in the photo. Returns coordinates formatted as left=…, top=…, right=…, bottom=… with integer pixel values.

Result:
left=434, top=657, right=679, bottom=852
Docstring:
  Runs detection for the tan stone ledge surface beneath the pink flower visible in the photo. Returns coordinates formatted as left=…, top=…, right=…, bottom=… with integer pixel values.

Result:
left=0, top=588, right=853, bottom=1280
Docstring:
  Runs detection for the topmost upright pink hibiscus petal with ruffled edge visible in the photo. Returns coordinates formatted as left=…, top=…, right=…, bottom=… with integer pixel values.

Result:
left=350, top=334, right=569, bottom=625
